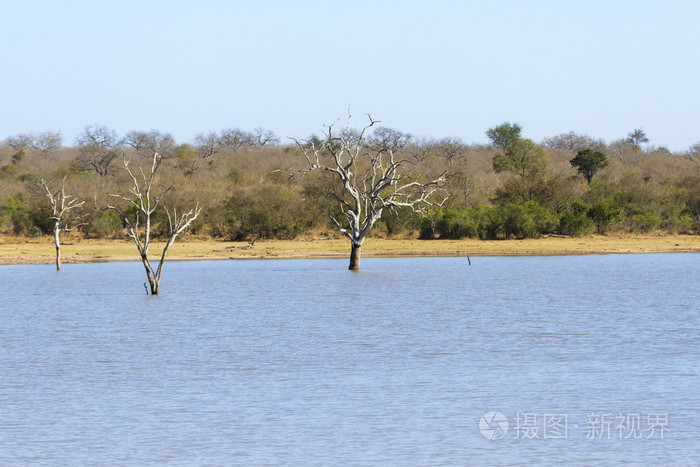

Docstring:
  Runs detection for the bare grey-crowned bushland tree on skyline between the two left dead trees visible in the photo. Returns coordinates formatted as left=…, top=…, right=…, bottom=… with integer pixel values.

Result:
left=76, top=126, right=118, bottom=178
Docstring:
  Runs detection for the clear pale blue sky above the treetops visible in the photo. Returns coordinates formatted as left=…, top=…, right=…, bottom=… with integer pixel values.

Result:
left=0, top=0, right=700, bottom=151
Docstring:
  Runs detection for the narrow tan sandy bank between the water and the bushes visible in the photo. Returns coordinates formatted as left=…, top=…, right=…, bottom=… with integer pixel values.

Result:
left=0, top=235, right=700, bottom=265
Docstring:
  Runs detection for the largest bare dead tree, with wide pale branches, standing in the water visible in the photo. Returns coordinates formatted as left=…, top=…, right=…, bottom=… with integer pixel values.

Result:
left=295, top=115, right=447, bottom=271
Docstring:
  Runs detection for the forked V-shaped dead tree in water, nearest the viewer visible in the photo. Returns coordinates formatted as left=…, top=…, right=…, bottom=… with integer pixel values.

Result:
left=104, top=152, right=202, bottom=295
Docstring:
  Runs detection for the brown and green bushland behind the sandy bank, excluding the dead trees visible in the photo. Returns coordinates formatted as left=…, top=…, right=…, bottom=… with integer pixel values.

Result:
left=0, top=123, right=700, bottom=240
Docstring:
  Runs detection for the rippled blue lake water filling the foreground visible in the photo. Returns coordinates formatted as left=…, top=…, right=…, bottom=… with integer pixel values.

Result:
left=0, top=254, right=700, bottom=465
